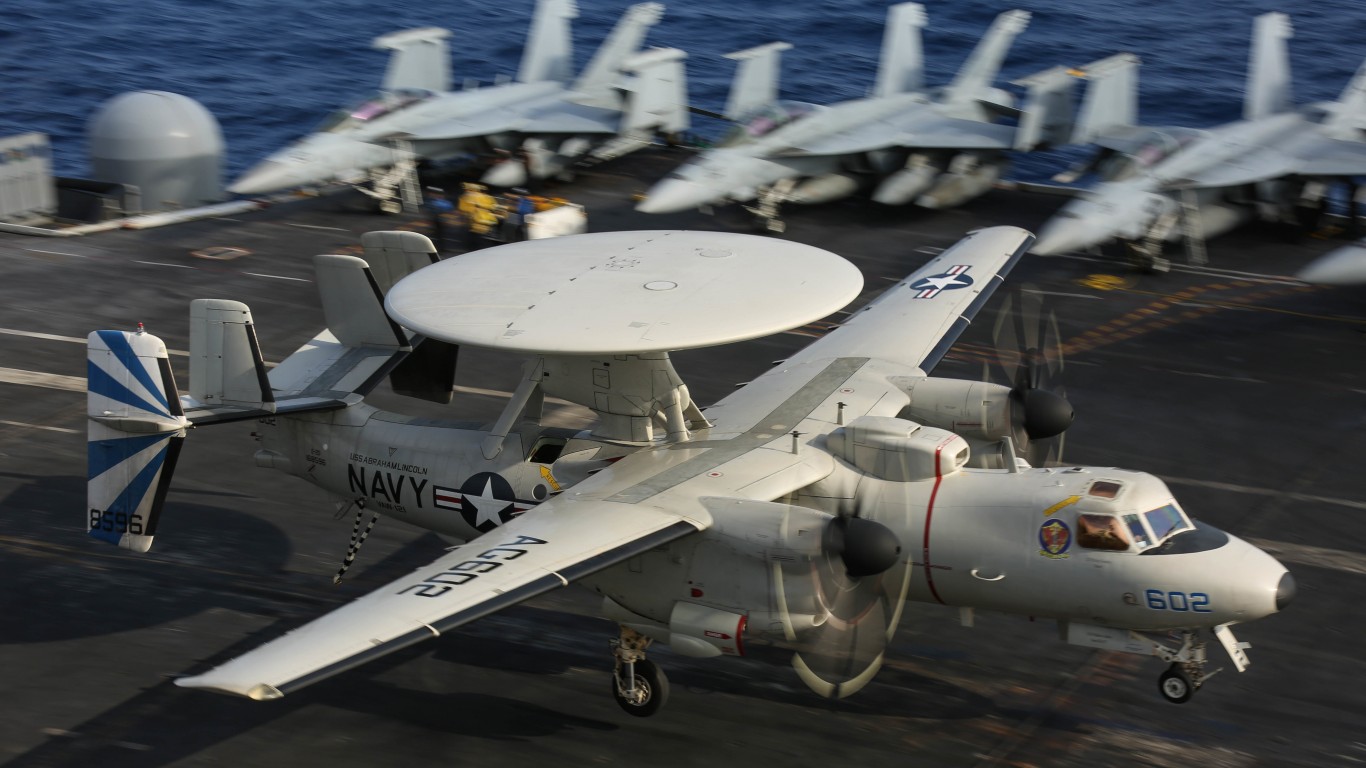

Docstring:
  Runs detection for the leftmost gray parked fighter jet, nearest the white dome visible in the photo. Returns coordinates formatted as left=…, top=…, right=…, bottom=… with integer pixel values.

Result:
left=228, top=0, right=688, bottom=201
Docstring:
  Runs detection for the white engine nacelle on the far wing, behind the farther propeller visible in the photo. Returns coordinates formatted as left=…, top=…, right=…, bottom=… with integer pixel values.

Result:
left=897, top=377, right=1011, bottom=441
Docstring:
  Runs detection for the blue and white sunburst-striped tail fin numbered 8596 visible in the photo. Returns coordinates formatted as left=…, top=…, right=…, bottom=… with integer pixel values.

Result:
left=86, top=331, right=190, bottom=552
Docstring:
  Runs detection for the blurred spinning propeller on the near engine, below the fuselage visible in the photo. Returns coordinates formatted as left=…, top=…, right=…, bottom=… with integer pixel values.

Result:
left=792, top=505, right=911, bottom=698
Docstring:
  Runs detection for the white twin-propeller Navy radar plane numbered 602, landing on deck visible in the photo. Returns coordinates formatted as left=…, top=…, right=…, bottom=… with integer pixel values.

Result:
left=89, top=227, right=1295, bottom=716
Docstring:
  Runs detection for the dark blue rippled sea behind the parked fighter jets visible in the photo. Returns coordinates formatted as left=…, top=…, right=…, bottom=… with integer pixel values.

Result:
left=0, top=0, right=1366, bottom=178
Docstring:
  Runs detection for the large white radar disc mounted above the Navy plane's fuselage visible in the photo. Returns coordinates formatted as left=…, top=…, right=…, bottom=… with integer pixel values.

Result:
left=385, top=231, right=863, bottom=354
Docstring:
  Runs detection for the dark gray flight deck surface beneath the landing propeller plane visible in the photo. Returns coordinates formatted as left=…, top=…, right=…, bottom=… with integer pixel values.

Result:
left=0, top=146, right=1366, bottom=768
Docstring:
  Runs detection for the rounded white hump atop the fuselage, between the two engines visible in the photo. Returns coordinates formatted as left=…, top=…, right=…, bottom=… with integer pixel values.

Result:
left=825, top=415, right=971, bottom=482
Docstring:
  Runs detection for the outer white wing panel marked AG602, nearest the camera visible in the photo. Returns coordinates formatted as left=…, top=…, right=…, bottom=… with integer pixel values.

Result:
left=176, top=497, right=710, bottom=701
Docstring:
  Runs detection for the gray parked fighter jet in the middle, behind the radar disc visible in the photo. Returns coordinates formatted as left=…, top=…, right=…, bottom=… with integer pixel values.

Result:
left=638, top=3, right=1074, bottom=228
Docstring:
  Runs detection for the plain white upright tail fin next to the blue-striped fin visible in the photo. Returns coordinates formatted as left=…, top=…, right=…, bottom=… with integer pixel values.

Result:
left=190, top=299, right=275, bottom=413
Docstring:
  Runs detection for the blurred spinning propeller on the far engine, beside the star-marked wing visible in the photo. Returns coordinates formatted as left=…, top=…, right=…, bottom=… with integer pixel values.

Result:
left=992, top=290, right=1072, bottom=466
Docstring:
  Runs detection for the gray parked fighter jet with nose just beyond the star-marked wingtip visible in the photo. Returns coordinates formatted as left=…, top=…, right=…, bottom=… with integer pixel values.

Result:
left=1034, top=14, right=1366, bottom=269
